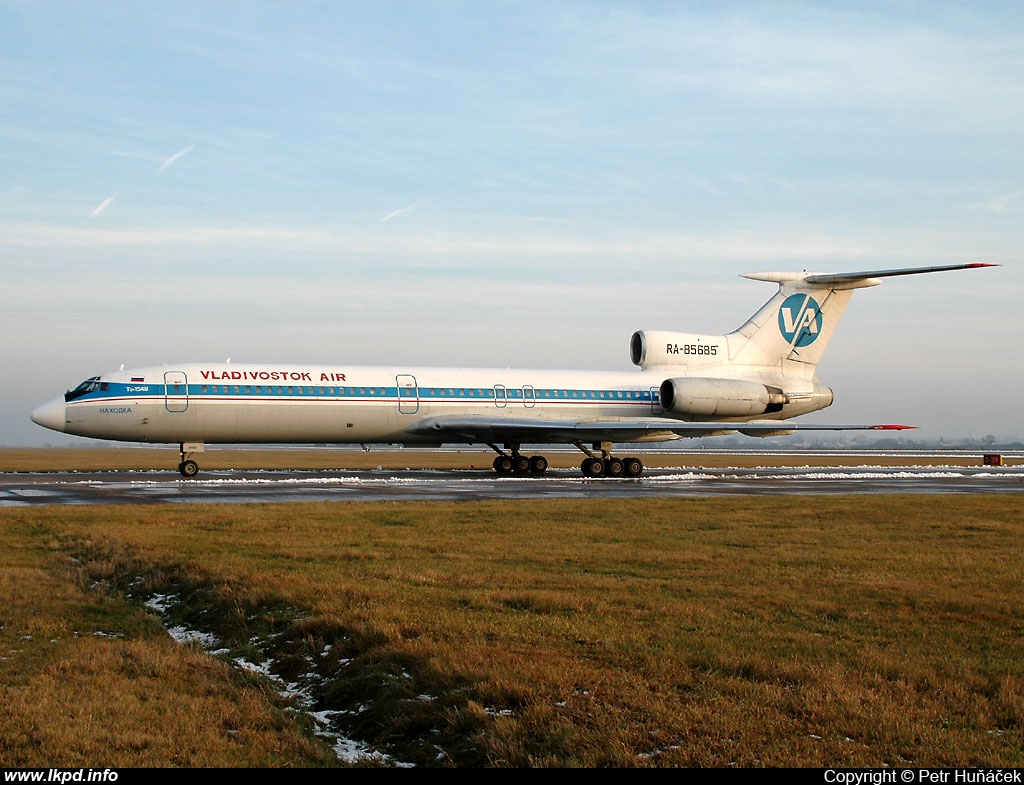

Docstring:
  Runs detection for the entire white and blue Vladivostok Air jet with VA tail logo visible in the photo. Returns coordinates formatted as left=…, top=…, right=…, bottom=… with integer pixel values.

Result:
left=32, top=264, right=995, bottom=477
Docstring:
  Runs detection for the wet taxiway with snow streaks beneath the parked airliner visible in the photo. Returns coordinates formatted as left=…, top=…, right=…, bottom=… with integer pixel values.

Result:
left=0, top=466, right=1024, bottom=507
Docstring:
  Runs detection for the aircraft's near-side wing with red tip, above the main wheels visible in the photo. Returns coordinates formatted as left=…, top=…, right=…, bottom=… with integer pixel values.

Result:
left=407, top=416, right=915, bottom=444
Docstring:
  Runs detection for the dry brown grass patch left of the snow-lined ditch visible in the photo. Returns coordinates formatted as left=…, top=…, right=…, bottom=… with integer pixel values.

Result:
left=0, top=532, right=333, bottom=768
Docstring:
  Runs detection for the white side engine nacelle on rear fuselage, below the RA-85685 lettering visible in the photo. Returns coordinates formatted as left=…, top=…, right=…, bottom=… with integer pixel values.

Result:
left=658, top=378, right=790, bottom=417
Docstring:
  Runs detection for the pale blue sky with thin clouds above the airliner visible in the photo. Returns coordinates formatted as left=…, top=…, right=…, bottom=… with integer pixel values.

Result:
left=0, top=0, right=1024, bottom=446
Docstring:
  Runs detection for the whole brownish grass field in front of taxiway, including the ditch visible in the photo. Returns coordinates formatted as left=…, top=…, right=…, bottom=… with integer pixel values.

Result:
left=0, top=462, right=1024, bottom=768
